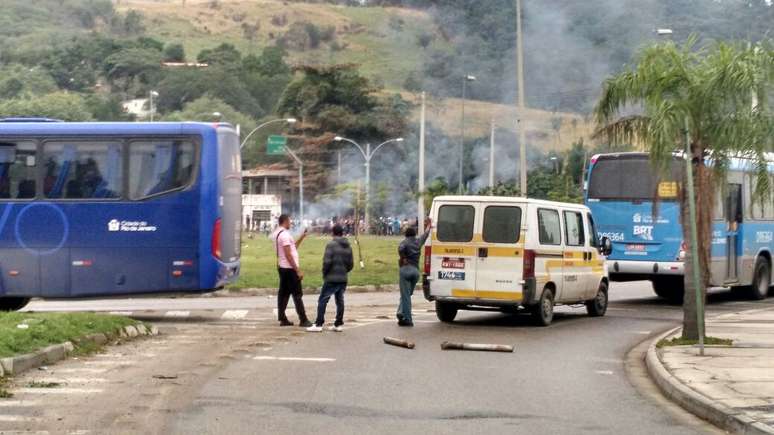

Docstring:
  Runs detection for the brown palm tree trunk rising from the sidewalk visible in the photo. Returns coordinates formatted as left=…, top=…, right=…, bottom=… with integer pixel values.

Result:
left=680, top=148, right=715, bottom=340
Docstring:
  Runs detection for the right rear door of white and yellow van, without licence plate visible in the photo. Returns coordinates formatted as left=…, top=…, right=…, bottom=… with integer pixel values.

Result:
left=476, top=205, right=524, bottom=302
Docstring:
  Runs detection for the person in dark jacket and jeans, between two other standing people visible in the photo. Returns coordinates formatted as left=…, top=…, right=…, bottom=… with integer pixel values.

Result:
left=306, top=224, right=354, bottom=332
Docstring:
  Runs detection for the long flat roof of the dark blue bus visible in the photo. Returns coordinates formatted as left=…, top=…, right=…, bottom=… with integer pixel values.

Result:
left=0, top=120, right=233, bottom=136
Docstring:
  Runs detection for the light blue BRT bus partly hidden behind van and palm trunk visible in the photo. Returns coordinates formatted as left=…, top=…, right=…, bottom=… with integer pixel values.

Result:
left=585, top=153, right=774, bottom=302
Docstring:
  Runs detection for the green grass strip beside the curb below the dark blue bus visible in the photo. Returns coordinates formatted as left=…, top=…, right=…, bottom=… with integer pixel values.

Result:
left=0, top=313, right=137, bottom=358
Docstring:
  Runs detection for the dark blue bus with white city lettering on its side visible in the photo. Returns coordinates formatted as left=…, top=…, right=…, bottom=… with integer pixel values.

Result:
left=0, top=119, right=242, bottom=310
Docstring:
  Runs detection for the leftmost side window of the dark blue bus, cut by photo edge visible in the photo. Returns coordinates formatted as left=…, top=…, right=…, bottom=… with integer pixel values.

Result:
left=0, top=142, right=37, bottom=199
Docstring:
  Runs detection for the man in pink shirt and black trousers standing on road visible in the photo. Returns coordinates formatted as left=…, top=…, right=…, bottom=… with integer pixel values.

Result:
left=272, top=214, right=312, bottom=327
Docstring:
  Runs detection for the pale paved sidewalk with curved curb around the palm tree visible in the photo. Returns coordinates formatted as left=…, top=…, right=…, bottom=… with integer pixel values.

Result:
left=646, top=308, right=774, bottom=434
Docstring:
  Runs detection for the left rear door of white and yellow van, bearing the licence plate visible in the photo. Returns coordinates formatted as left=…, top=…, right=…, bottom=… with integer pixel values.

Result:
left=428, top=203, right=478, bottom=299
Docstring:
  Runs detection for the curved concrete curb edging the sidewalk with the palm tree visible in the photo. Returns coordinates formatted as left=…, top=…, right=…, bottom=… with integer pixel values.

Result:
left=645, top=327, right=774, bottom=435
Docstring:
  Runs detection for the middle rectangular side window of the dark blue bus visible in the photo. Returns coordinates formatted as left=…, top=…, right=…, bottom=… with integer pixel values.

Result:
left=43, top=141, right=123, bottom=199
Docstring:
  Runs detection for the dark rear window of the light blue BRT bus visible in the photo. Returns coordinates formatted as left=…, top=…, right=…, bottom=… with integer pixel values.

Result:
left=588, top=154, right=682, bottom=201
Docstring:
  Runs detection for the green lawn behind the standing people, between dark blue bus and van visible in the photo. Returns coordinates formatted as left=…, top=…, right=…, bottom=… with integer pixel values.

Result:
left=232, top=235, right=401, bottom=288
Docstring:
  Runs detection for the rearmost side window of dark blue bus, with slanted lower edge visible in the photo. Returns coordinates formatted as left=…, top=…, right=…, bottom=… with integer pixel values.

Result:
left=129, top=140, right=196, bottom=199
